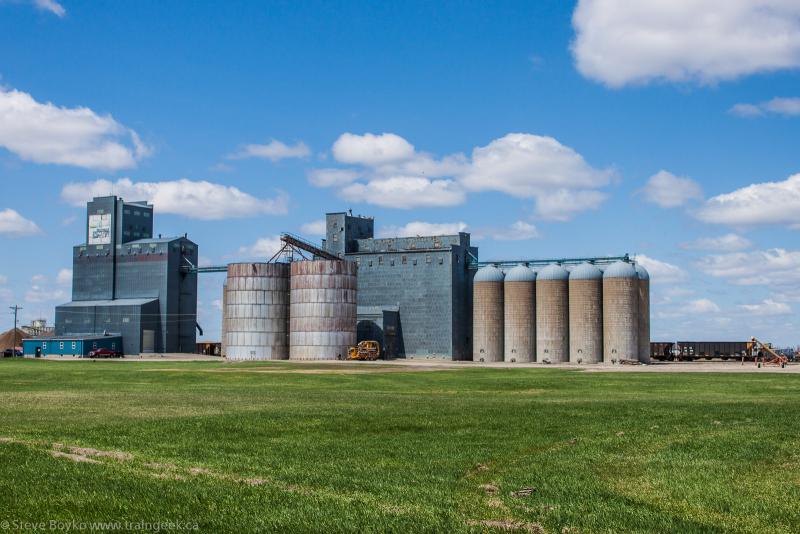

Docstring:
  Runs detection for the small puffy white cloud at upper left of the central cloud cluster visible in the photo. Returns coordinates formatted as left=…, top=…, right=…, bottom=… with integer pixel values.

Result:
left=333, top=133, right=414, bottom=167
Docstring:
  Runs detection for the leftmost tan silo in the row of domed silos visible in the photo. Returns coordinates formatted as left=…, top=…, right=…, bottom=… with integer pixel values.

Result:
left=472, top=265, right=505, bottom=362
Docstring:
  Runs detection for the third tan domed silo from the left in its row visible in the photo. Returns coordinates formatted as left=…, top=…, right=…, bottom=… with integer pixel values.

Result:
left=536, top=264, right=569, bottom=363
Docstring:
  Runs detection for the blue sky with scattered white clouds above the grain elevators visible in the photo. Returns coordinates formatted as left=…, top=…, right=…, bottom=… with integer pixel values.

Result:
left=0, top=0, right=800, bottom=344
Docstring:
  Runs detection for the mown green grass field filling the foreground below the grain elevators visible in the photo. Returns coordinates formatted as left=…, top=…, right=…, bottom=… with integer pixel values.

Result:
left=0, top=360, right=800, bottom=533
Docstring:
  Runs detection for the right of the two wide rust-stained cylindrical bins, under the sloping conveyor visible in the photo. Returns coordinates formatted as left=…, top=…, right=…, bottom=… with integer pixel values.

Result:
left=289, top=260, right=358, bottom=360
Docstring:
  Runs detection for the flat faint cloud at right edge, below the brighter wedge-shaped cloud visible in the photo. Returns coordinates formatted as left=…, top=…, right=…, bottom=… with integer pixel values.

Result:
left=697, top=248, right=800, bottom=287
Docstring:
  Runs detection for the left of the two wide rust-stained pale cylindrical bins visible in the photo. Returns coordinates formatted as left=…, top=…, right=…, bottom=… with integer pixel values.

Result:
left=223, top=263, right=289, bottom=360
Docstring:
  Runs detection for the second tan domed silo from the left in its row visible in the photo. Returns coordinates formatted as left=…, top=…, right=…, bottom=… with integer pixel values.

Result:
left=503, top=265, right=536, bottom=362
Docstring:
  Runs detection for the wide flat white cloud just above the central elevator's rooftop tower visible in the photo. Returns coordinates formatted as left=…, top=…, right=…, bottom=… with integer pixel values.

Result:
left=340, top=176, right=466, bottom=209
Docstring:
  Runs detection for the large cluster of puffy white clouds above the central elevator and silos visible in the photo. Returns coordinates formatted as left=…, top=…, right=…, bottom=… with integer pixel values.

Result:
left=316, top=133, right=614, bottom=220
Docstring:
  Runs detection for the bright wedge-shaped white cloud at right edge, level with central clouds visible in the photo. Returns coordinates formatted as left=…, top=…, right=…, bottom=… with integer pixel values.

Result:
left=696, top=174, right=800, bottom=226
